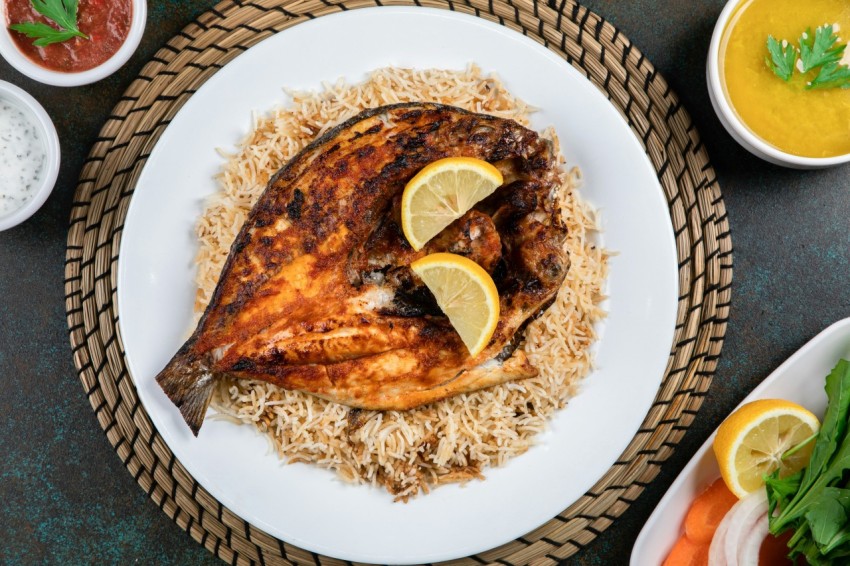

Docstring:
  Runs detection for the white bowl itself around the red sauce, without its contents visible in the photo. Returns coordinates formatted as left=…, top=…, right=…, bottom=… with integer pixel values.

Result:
left=0, top=0, right=148, bottom=86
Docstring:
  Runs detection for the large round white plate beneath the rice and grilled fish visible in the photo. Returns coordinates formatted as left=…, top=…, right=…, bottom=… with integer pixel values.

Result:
left=118, top=8, right=678, bottom=564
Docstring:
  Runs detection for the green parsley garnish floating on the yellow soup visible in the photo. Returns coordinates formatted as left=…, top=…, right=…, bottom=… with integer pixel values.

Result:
left=764, top=25, right=850, bottom=89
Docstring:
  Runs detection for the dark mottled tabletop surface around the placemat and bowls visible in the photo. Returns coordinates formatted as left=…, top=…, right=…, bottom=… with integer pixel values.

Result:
left=0, top=0, right=850, bottom=565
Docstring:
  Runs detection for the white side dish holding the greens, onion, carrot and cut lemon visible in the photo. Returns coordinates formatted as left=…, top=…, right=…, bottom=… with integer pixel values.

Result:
left=631, top=318, right=850, bottom=566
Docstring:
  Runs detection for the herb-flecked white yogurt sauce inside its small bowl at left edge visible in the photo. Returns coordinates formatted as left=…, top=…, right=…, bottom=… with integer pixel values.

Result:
left=0, top=97, right=47, bottom=217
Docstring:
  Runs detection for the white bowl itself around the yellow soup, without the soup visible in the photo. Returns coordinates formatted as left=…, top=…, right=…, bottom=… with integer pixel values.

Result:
left=706, top=0, right=850, bottom=169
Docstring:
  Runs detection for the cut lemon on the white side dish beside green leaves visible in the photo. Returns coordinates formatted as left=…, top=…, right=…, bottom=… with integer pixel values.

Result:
left=714, top=399, right=820, bottom=497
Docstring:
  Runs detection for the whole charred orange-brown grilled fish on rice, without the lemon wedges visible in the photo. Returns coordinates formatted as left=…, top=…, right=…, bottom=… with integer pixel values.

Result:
left=156, top=103, right=569, bottom=434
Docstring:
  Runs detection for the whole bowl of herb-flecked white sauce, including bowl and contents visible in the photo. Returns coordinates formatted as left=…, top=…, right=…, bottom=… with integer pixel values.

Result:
left=0, top=81, right=60, bottom=231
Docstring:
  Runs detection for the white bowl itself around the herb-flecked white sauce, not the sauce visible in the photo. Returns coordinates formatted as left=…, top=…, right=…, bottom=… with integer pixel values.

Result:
left=0, top=81, right=61, bottom=232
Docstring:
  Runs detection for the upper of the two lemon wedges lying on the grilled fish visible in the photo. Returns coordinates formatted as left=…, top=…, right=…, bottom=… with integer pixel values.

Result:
left=401, top=157, right=503, bottom=251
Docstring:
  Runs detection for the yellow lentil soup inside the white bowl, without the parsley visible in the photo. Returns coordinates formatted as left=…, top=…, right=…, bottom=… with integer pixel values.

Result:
left=719, top=0, right=850, bottom=157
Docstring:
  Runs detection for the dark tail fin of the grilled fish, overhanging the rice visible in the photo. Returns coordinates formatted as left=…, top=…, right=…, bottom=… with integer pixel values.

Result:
left=156, top=340, right=218, bottom=436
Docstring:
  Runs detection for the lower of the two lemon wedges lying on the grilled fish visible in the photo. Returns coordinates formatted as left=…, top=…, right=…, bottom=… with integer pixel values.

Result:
left=410, top=253, right=499, bottom=357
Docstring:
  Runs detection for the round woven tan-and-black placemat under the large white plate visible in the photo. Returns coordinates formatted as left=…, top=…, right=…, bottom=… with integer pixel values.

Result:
left=65, top=0, right=732, bottom=565
